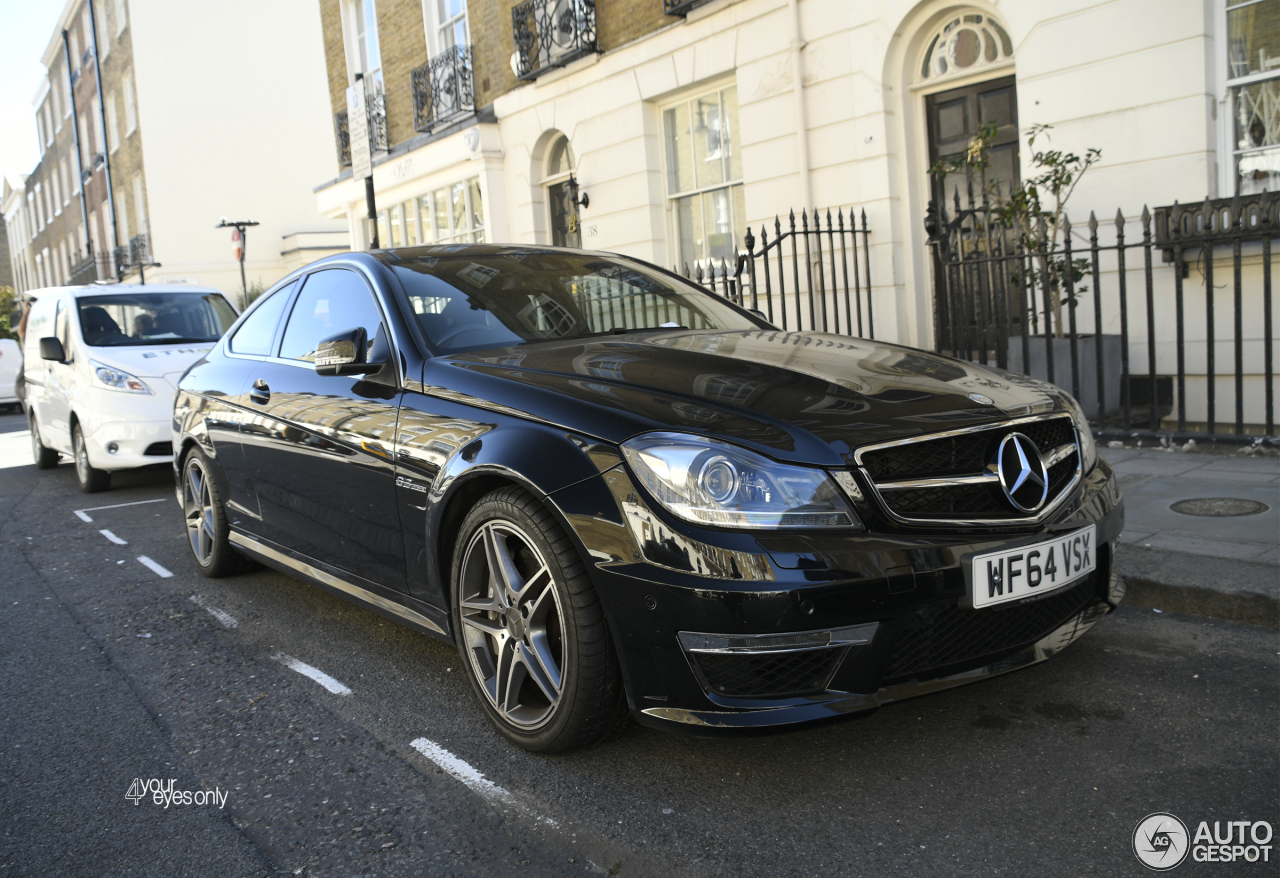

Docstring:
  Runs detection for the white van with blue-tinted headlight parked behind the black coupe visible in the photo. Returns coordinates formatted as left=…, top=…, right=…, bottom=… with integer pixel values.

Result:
left=23, top=284, right=237, bottom=493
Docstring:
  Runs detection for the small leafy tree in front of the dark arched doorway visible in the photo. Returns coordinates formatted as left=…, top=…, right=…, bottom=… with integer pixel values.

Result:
left=929, top=122, right=1102, bottom=338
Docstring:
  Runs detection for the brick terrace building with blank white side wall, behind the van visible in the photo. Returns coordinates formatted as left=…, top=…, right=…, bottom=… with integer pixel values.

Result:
left=4, top=0, right=348, bottom=302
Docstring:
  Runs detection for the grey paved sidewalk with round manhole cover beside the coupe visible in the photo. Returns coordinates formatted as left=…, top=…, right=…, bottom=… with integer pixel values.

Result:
left=1101, top=448, right=1280, bottom=627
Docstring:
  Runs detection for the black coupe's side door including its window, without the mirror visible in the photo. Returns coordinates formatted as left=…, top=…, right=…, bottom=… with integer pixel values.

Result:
left=236, top=267, right=404, bottom=590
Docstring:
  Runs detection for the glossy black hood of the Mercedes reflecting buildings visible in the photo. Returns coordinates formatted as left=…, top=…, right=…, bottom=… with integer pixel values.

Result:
left=424, top=330, right=1069, bottom=466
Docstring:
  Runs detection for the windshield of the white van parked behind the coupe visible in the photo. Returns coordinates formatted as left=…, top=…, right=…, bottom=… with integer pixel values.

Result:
left=78, top=293, right=236, bottom=347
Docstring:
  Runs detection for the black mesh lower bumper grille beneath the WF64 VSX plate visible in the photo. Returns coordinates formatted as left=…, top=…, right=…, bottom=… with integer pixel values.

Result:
left=884, top=572, right=1098, bottom=682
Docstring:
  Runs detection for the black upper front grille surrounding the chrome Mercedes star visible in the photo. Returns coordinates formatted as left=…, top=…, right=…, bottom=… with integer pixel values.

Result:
left=859, top=415, right=1079, bottom=523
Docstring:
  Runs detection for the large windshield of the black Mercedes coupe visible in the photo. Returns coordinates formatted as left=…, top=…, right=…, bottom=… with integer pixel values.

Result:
left=389, top=250, right=759, bottom=353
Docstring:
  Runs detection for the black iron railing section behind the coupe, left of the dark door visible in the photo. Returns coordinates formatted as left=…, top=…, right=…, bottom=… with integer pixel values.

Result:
left=676, top=207, right=876, bottom=338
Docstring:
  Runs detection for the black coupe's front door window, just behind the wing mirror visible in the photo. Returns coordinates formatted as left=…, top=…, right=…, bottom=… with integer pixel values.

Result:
left=280, top=269, right=383, bottom=362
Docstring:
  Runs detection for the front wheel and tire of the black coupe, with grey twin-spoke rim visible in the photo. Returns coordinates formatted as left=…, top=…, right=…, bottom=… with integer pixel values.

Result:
left=451, top=488, right=626, bottom=753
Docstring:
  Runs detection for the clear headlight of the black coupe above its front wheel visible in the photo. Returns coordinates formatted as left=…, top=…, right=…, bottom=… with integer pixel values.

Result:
left=622, top=433, right=863, bottom=529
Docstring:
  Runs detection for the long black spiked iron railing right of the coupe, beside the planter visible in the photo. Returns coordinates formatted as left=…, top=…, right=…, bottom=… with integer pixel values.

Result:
left=925, top=192, right=1280, bottom=438
